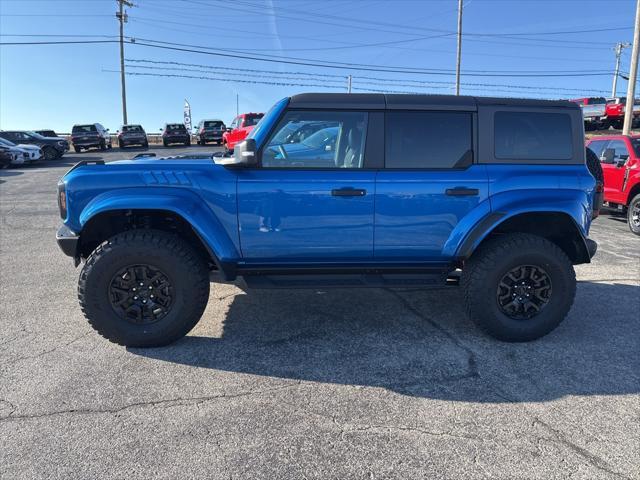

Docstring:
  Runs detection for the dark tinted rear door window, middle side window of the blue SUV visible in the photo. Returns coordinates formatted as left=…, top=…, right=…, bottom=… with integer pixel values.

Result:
left=385, top=112, right=473, bottom=169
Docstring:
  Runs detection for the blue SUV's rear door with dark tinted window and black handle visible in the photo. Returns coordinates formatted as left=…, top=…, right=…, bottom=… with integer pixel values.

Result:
left=375, top=110, right=489, bottom=261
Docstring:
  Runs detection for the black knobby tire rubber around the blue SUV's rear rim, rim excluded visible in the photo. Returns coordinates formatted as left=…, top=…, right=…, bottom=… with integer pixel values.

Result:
left=461, top=233, right=576, bottom=342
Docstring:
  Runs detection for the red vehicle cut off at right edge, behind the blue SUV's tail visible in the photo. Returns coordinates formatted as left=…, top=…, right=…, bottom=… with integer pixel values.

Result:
left=587, top=135, right=640, bottom=235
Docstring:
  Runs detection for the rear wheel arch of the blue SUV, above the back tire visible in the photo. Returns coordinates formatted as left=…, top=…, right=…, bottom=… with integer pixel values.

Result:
left=456, top=211, right=592, bottom=265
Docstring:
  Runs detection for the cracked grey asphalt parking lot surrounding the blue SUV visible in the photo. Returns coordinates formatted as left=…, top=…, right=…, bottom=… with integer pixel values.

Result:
left=0, top=147, right=640, bottom=479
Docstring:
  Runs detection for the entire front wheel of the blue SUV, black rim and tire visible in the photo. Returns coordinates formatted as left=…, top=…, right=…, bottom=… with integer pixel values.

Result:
left=78, top=230, right=209, bottom=347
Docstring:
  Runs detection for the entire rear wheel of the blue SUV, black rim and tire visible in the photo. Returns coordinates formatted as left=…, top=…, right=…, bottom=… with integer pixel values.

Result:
left=462, top=233, right=576, bottom=342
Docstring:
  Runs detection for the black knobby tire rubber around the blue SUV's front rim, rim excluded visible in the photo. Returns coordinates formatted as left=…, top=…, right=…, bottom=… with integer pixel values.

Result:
left=78, top=230, right=209, bottom=347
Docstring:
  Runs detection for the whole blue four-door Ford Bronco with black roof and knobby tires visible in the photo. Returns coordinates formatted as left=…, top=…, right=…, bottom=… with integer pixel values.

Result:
left=57, top=94, right=597, bottom=347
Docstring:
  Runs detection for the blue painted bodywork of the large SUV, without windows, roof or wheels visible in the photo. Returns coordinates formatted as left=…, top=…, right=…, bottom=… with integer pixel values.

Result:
left=57, top=95, right=595, bottom=278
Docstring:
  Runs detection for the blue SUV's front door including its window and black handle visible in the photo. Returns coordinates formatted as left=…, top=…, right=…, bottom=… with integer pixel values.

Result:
left=238, top=111, right=375, bottom=264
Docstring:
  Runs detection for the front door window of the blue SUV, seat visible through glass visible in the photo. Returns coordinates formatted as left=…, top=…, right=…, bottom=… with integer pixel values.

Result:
left=262, top=111, right=368, bottom=168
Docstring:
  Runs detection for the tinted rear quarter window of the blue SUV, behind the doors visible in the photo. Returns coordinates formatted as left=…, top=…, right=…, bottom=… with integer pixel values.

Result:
left=494, top=112, right=573, bottom=160
